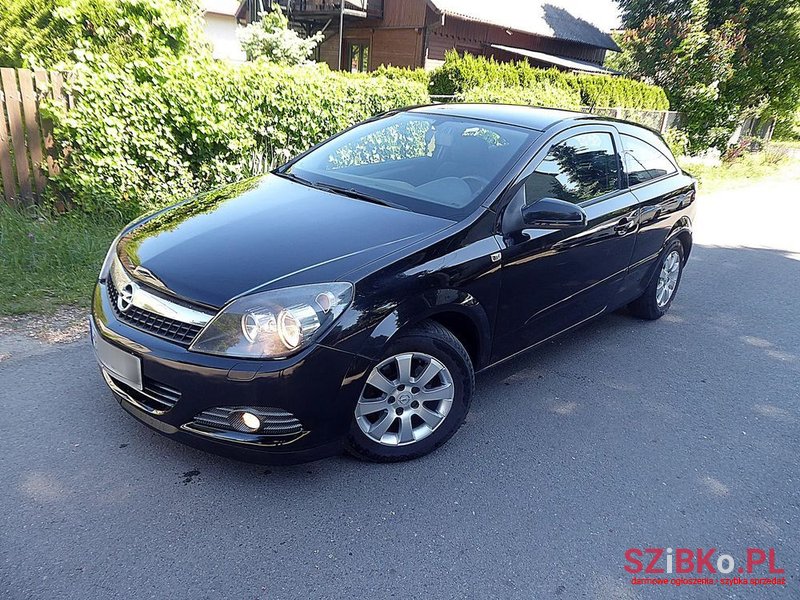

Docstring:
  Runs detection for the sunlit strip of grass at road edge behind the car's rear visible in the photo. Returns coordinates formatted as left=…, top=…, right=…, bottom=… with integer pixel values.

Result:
left=678, top=145, right=796, bottom=193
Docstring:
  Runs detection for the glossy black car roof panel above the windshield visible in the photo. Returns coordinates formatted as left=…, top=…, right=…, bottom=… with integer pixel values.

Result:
left=409, top=103, right=600, bottom=131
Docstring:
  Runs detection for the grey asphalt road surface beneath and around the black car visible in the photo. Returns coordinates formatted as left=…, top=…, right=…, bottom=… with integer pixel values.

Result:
left=0, top=170, right=800, bottom=600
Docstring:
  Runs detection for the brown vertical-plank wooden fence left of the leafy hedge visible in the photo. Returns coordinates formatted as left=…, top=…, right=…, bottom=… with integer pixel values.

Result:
left=0, top=68, right=67, bottom=207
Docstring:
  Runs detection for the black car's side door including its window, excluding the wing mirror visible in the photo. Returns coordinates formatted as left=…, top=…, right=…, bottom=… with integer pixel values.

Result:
left=493, top=124, right=639, bottom=360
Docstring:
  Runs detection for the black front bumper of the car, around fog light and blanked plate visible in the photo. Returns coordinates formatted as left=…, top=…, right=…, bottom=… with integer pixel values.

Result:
left=90, top=282, right=371, bottom=464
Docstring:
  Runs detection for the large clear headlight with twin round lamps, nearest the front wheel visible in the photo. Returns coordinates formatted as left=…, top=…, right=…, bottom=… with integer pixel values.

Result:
left=189, top=283, right=353, bottom=358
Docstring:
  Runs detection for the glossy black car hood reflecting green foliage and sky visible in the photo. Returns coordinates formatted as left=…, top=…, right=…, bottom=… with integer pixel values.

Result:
left=117, top=175, right=452, bottom=307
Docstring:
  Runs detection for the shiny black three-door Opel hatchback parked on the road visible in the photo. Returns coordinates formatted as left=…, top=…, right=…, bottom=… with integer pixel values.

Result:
left=91, top=104, right=696, bottom=462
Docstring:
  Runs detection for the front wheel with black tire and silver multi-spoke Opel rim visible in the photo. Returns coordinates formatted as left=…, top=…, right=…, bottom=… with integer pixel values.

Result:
left=345, top=321, right=475, bottom=463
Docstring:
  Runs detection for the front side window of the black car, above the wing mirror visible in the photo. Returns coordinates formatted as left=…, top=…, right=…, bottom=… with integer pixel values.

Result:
left=525, top=132, right=619, bottom=204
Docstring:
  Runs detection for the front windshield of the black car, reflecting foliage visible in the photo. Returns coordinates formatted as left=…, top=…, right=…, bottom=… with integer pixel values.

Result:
left=278, top=112, right=539, bottom=220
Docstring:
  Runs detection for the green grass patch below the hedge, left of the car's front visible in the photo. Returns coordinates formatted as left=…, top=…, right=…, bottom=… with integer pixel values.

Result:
left=0, top=205, right=125, bottom=315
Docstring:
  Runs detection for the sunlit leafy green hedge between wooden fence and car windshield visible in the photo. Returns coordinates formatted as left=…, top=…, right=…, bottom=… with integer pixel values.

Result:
left=45, top=60, right=429, bottom=215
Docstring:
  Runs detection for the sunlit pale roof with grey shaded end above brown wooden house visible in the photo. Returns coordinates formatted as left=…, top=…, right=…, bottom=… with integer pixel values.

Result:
left=429, top=0, right=620, bottom=52
